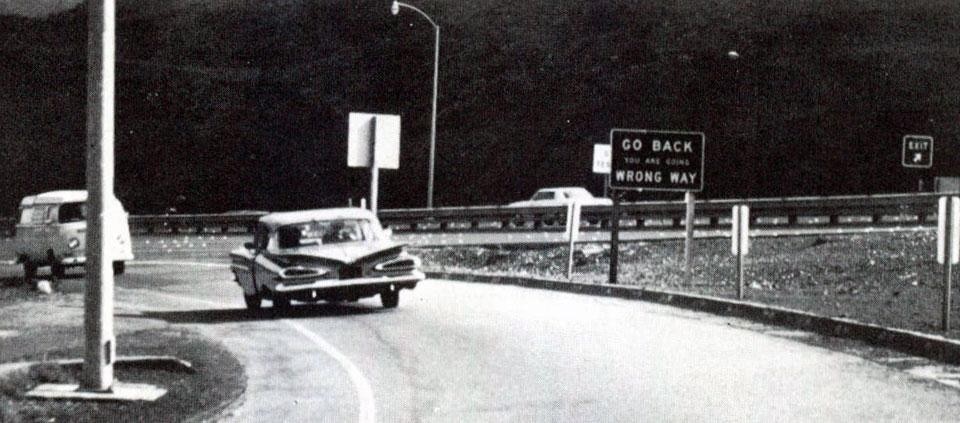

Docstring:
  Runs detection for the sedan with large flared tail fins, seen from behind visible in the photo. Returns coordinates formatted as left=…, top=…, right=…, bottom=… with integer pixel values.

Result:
left=230, top=208, right=425, bottom=309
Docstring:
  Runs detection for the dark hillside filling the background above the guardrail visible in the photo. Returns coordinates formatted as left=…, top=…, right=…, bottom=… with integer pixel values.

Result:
left=0, top=0, right=960, bottom=214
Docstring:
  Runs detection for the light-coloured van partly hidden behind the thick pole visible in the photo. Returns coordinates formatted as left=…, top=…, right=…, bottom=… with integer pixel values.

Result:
left=14, top=190, right=133, bottom=281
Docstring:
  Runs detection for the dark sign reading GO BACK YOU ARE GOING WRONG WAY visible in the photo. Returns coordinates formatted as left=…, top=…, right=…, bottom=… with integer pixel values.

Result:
left=610, top=129, right=706, bottom=191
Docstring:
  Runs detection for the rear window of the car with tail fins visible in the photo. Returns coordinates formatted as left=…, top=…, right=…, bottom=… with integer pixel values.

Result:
left=277, top=219, right=374, bottom=248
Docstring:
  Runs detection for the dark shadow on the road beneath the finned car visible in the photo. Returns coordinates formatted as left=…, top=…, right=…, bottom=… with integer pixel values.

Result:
left=124, top=303, right=380, bottom=324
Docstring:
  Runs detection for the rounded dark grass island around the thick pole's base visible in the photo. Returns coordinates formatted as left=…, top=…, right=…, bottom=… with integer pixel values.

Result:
left=0, top=329, right=246, bottom=423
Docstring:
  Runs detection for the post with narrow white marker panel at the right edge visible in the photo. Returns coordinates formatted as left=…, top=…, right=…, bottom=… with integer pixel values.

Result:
left=937, top=197, right=960, bottom=332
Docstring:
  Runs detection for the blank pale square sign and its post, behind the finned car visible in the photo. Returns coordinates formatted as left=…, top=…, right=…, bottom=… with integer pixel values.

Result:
left=347, top=113, right=400, bottom=213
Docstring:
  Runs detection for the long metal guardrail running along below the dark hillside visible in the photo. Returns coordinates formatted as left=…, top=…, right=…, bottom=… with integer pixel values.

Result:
left=0, top=193, right=945, bottom=236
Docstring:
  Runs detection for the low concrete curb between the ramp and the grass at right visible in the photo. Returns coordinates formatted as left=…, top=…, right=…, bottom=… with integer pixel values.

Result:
left=426, top=272, right=960, bottom=364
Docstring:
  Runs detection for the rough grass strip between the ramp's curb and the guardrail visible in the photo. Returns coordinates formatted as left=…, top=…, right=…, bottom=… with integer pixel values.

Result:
left=413, top=232, right=960, bottom=338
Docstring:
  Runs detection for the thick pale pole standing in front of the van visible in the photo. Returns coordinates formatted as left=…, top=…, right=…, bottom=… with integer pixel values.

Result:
left=82, top=0, right=116, bottom=391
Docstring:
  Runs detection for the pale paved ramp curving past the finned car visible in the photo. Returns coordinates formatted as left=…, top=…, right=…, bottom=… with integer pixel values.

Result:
left=107, top=264, right=960, bottom=422
